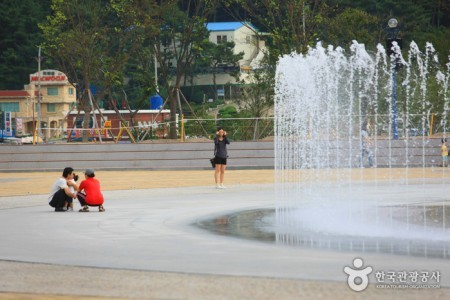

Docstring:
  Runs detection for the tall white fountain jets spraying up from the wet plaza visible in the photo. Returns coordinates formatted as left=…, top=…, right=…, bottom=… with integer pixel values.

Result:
left=275, top=42, right=450, bottom=258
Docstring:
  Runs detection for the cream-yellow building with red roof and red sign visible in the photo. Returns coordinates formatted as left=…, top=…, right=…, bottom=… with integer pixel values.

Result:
left=0, top=70, right=76, bottom=139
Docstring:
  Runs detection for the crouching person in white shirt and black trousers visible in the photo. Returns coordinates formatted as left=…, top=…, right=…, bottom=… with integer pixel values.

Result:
left=48, top=167, right=77, bottom=211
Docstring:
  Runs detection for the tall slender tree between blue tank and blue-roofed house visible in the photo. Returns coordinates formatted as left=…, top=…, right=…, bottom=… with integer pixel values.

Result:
left=153, top=0, right=220, bottom=139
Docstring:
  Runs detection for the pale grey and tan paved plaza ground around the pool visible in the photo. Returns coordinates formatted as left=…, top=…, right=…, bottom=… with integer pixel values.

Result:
left=0, top=169, right=450, bottom=299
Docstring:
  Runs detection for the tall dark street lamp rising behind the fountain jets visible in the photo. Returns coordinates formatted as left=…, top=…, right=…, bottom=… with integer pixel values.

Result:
left=386, top=18, right=402, bottom=140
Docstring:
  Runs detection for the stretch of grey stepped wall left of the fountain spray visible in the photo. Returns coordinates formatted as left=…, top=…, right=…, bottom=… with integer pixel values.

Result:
left=0, top=142, right=274, bottom=171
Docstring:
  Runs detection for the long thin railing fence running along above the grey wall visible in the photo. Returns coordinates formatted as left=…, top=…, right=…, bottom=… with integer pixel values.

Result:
left=13, top=113, right=450, bottom=142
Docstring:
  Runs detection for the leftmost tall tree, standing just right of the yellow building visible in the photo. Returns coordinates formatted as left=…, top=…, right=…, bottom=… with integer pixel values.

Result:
left=40, top=0, right=112, bottom=142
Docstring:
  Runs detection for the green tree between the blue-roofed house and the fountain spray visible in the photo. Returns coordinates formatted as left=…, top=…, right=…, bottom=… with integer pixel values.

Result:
left=224, top=0, right=327, bottom=134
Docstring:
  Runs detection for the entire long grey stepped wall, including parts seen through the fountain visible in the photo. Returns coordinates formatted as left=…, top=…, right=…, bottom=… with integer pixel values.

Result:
left=0, top=138, right=441, bottom=171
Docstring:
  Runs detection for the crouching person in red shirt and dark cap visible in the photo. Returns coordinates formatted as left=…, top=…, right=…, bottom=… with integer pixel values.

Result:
left=77, top=169, right=105, bottom=212
